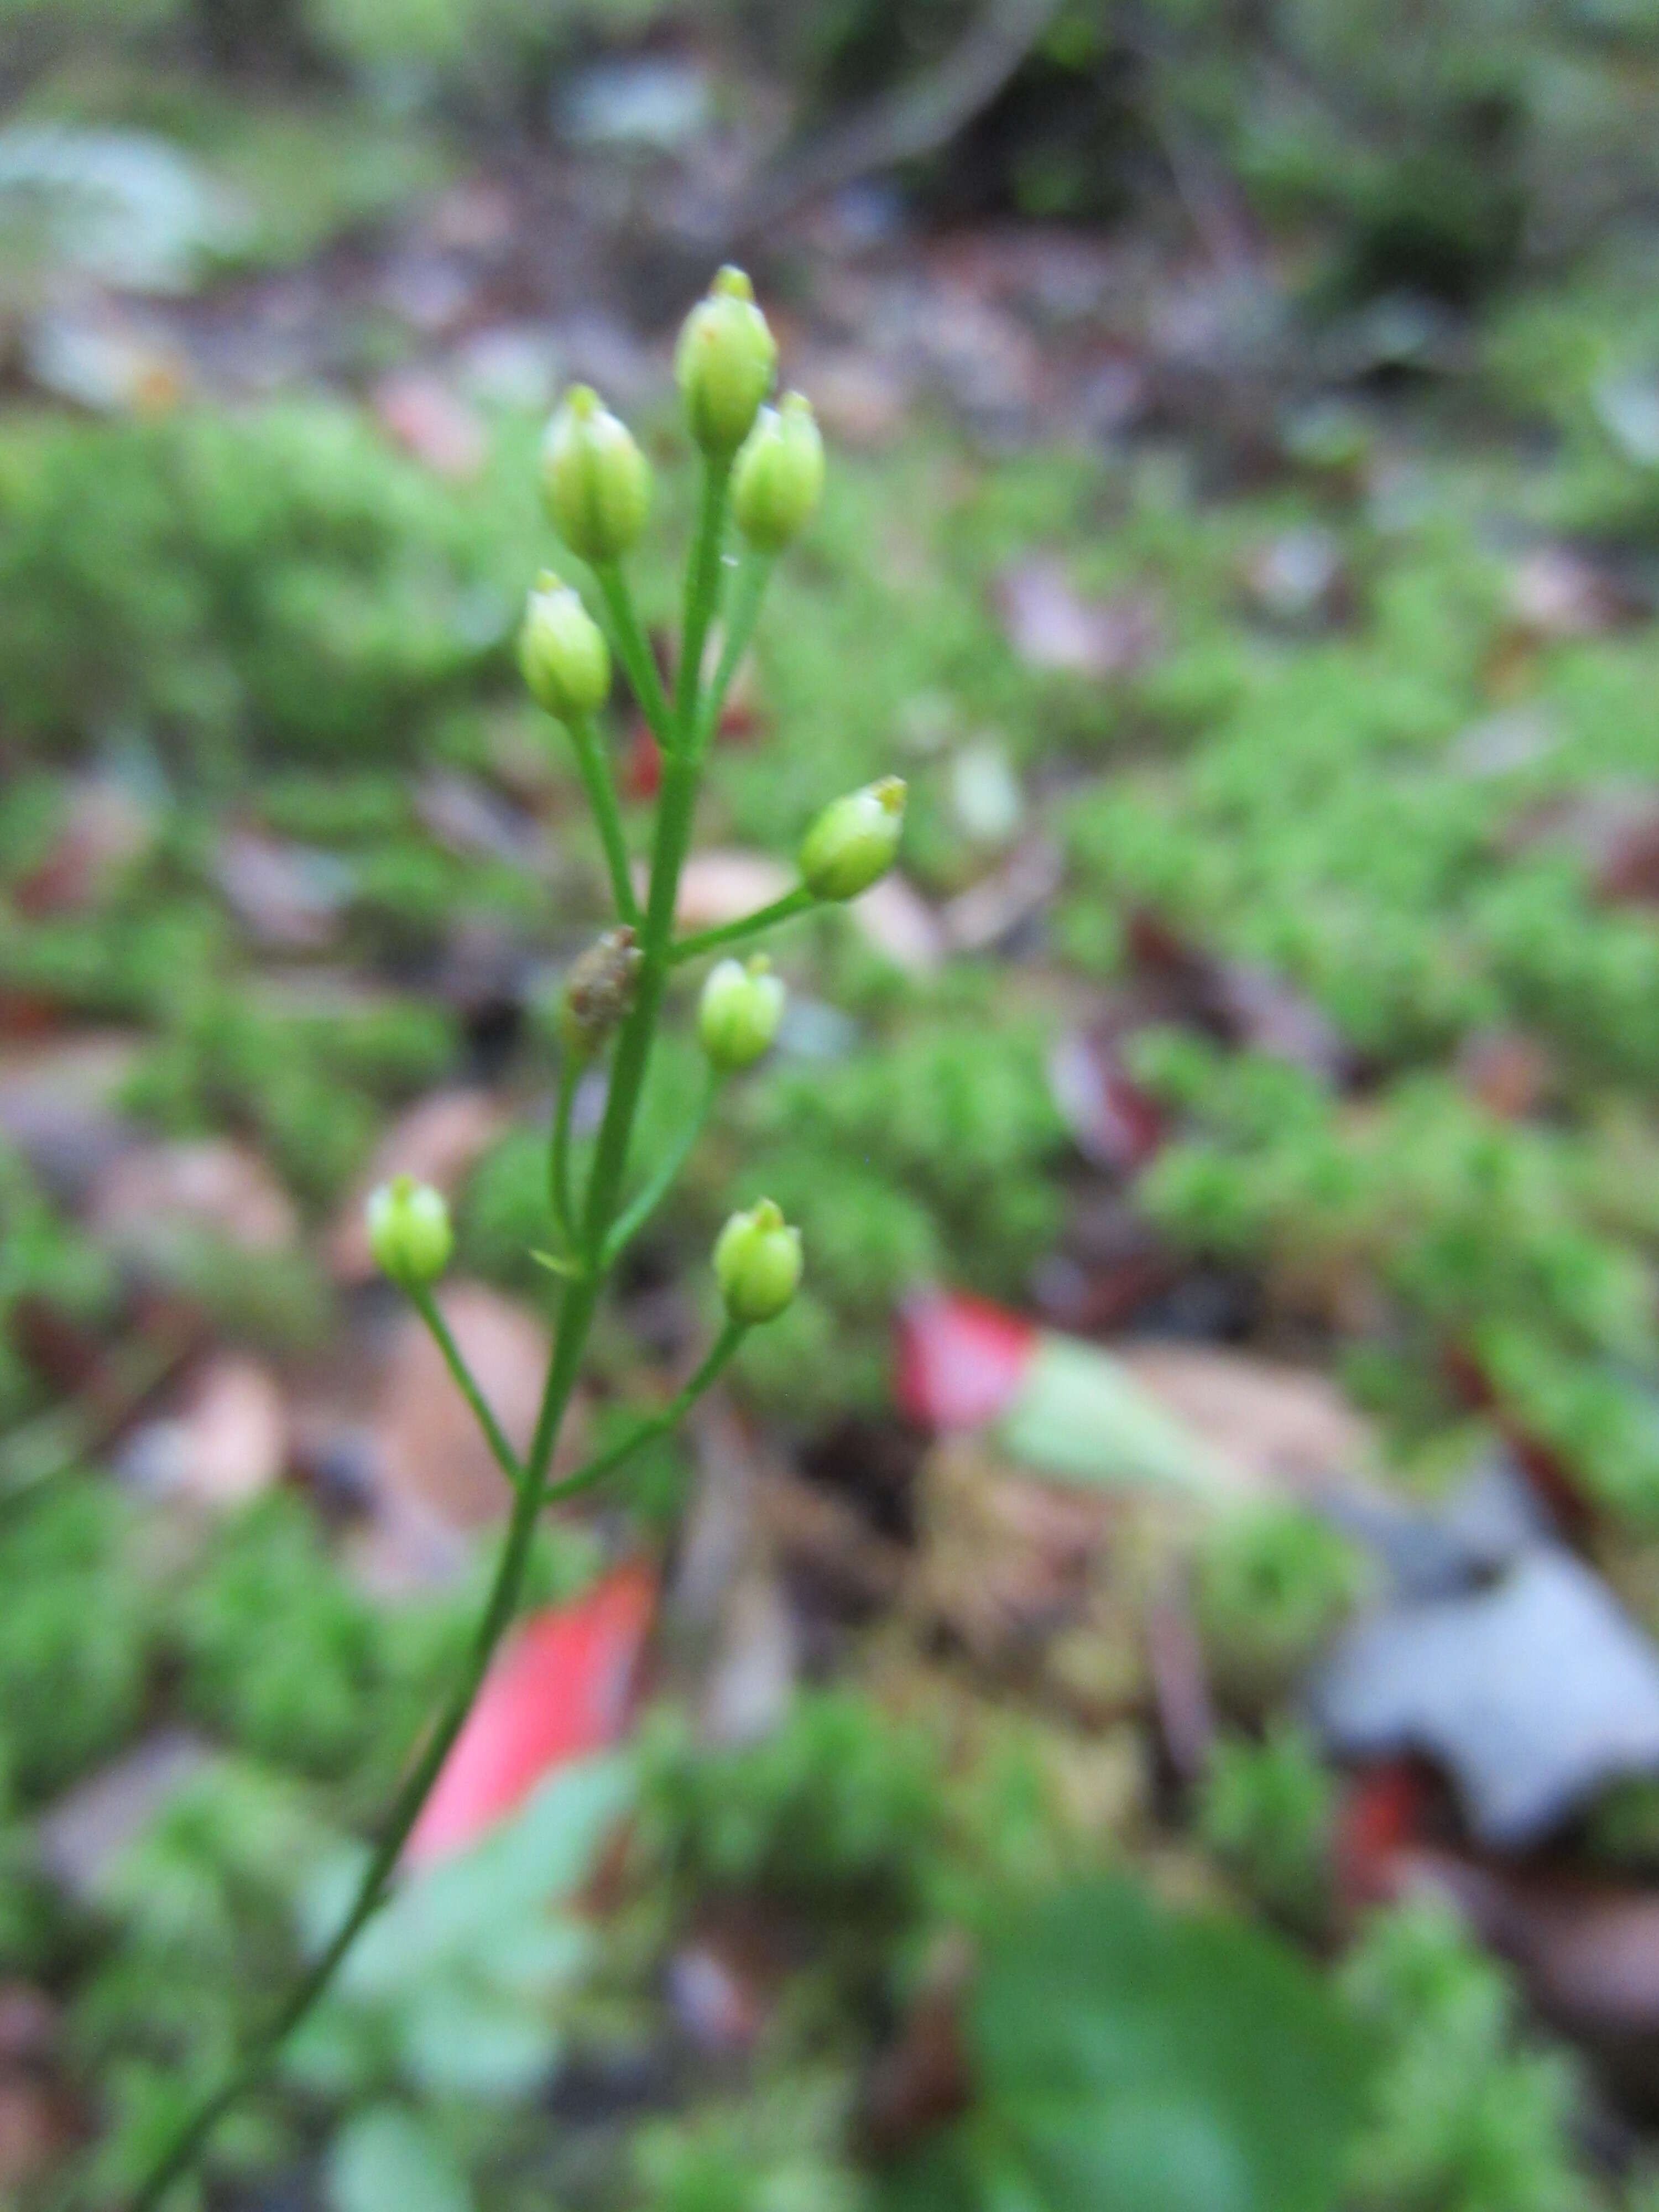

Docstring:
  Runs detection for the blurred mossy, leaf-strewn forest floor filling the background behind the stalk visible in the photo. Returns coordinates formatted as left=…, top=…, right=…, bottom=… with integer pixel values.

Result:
left=0, top=0, right=1659, bottom=2212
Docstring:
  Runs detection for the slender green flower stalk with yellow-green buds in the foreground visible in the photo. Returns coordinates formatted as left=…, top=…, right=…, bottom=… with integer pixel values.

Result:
left=131, top=268, right=905, bottom=2212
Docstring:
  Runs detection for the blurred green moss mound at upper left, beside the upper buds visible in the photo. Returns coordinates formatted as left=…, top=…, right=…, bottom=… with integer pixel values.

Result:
left=0, top=403, right=535, bottom=783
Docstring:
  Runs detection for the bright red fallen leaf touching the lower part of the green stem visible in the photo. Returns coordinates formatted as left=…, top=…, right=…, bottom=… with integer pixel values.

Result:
left=407, top=1562, right=657, bottom=1865
